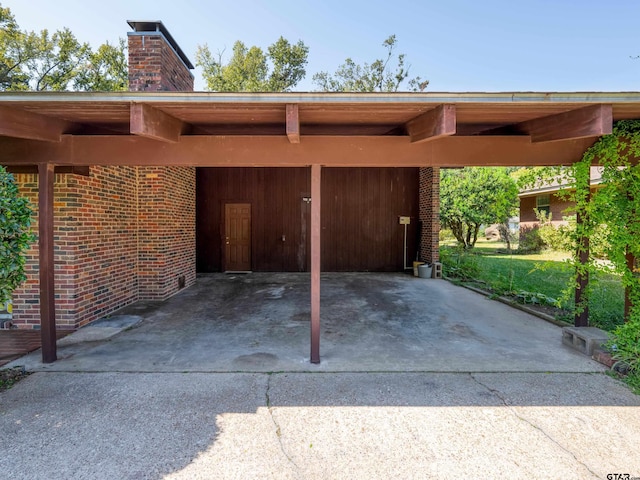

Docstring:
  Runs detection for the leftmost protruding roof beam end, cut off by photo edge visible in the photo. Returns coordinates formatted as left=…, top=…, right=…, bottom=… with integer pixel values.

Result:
left=0, top=106, right=71, bottom=142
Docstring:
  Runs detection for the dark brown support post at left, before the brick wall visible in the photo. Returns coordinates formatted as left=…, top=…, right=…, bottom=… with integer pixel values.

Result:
left=38, top=163, right=57, bottom=363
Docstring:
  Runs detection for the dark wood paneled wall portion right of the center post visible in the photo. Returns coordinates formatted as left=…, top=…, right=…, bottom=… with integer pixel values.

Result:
left=322, top=168, right=419, bottom=272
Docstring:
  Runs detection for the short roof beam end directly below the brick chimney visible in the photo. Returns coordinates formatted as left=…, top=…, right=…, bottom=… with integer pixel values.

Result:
left=129, top=103, right=184, bottom=143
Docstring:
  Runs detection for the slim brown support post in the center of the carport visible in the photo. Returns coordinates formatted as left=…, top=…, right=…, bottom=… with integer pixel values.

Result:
left=311, top=165, right=321, bottom=363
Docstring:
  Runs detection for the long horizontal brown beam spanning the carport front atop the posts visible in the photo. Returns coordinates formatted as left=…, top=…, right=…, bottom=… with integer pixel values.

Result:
left=0, top=135, right=596, bottom=167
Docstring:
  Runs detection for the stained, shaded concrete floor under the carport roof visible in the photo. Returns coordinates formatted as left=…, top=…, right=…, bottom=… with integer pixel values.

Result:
left=12, top=273, right=604, bottom=372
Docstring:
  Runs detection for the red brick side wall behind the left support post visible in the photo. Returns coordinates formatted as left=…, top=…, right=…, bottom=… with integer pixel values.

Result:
left=13, top=167, right=138, bottom=328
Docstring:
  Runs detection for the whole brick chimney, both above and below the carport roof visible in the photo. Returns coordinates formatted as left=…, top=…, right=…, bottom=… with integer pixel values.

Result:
left=128, top=21, right=196, bottom=300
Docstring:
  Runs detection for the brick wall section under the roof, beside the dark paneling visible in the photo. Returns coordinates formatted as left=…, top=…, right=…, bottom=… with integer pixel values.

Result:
left=138, top=167, right=196, bottom=300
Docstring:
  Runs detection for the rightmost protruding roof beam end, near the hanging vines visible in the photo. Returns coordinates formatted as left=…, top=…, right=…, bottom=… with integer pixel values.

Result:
left=515, top=105, right=613, bottom=143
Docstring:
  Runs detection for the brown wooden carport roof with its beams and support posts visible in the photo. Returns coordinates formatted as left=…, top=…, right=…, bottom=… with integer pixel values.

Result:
left=0, top=92, right=640, bottom=363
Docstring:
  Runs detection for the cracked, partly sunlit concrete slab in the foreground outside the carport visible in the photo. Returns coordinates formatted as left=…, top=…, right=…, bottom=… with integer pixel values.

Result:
left=0, top=372, right=640, bottom=479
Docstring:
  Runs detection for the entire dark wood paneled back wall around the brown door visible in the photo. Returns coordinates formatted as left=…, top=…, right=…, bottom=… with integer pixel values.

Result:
left=196, top=167, right=419, bottom=272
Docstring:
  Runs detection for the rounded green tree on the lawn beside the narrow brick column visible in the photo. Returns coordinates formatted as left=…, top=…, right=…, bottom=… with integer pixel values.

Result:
left=440, top=167, right=518, bottom=249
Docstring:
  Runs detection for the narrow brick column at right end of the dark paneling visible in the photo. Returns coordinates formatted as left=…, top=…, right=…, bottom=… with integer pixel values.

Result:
left=420, top=167, right=440, bottom=263
